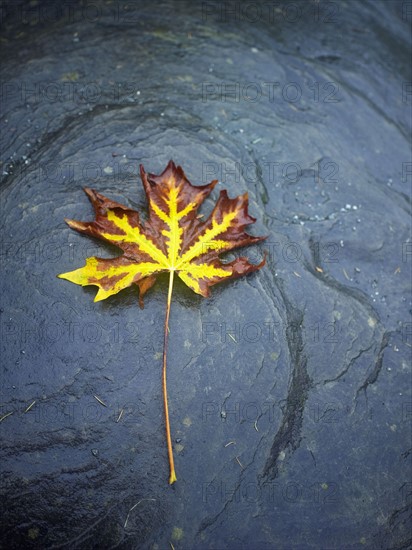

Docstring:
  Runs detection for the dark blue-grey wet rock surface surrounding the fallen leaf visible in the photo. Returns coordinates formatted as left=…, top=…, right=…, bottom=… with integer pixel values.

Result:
left=0, top=1, right=412, bottom=550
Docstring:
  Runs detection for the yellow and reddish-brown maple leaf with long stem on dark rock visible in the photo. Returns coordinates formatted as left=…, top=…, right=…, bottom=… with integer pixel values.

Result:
left=58, top=161, right=266, bottom=483
